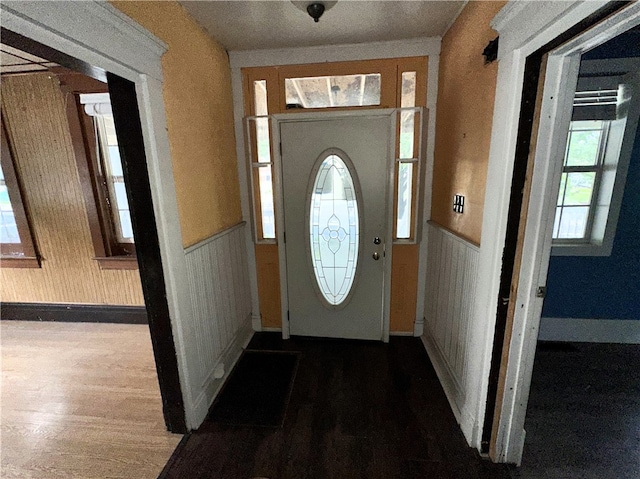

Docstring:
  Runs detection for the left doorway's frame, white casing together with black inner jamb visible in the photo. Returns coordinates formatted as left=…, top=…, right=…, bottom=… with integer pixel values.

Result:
left=2, top=0, right=196, bottom=433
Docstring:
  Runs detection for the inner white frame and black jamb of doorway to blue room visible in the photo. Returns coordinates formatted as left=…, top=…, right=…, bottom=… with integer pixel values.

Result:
left=491, top=2, right=640, bottom=464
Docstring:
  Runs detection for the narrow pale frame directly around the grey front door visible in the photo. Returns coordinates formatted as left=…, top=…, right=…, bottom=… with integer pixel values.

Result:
left=271, top=108, right=398, bottom=343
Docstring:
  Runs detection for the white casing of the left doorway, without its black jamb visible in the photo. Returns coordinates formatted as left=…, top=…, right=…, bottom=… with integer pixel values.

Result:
left=2, top=0, right=202, bottom=428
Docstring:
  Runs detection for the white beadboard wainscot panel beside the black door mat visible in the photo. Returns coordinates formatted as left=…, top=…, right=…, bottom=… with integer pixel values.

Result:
left=185, top=223, right=253, bottom=427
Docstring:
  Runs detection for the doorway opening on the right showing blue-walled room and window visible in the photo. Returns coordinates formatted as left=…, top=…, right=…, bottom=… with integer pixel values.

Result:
left=521, top=27, right=640, bottom=477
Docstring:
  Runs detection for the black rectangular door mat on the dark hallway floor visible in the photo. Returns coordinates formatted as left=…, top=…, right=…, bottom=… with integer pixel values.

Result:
left=208, top=351, right=299, bottom=427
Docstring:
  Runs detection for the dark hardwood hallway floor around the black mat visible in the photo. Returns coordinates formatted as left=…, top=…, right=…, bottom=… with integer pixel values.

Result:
left=160, top=333, right=509, bottom=479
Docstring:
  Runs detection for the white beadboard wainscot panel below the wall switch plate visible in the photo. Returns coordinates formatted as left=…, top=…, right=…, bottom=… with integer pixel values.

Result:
left=422, top=224, right=479, bottom=422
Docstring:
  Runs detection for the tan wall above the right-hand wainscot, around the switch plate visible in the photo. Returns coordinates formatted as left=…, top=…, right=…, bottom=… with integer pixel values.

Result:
left=431, top=1, right=506, bottom=244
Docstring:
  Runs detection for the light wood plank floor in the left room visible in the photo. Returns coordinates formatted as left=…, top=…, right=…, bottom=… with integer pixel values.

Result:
left=0, top=321, right=181, bottom=479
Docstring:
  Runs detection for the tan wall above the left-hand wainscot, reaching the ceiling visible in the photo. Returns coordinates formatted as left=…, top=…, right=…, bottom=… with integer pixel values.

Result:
left=112, top=1, right=242, bottom=247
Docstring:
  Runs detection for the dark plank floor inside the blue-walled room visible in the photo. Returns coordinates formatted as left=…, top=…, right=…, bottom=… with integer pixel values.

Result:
left=514, top=343, right=640, bottom=479
